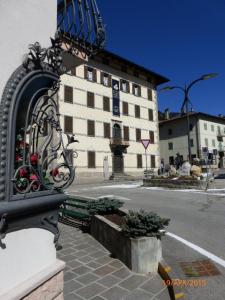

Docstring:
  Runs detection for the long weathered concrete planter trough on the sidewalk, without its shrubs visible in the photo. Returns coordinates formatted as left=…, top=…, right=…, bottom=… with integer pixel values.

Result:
left=90, top=215, right=162, bottom=274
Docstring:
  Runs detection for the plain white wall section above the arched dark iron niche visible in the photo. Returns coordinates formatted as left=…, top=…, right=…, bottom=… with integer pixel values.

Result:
left=0, top=0, right=57, bottom=98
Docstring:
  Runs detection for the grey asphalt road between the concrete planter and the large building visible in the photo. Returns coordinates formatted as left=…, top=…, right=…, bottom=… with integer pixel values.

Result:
left=67, top=182, right=225, bottom=300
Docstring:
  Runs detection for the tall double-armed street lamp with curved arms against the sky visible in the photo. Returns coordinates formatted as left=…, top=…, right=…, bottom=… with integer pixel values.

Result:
left=160, top=73, right=218, bottom=162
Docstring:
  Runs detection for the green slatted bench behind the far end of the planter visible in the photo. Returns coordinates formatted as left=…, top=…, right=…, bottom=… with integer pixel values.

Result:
left=59, top=195, right=94, bottom=223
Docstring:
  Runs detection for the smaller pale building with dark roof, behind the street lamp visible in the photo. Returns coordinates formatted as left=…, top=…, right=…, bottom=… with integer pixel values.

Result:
left=159, top=112, right=225, bottom=167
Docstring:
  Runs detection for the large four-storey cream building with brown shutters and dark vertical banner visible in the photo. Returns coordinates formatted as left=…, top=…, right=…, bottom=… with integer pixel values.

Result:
left=59, top=51, right=168, bottom=179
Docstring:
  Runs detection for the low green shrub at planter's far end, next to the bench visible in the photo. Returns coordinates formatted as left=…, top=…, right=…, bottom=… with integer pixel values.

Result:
left=88, top=197, right=123, bottom=215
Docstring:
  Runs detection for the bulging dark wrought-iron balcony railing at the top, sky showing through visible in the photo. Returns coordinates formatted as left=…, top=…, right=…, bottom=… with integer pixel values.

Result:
left=57, top=0, right=105, bottom=55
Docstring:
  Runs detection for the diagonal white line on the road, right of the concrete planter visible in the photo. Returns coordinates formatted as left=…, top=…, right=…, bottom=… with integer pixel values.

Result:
left=166, top=232, right=225, bottom=268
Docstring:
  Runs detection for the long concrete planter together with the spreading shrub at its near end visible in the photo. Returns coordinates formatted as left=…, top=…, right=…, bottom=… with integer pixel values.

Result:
left=91, top=206, right=169, bottom=274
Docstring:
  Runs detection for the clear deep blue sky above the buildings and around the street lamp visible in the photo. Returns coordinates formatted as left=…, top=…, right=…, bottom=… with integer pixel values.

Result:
left=97, top=0, right=225, bottom=115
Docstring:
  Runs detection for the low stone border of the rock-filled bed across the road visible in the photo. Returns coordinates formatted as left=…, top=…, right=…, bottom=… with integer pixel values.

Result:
left=143, top=178, right=204, bottom=189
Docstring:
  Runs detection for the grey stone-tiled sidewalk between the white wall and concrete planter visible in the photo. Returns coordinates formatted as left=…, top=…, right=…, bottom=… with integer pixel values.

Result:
left=57, top=224, right=170, bottom=300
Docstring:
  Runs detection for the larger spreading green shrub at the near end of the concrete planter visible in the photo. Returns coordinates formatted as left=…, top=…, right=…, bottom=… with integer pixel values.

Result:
left=120, top=210, right=170, bottom=239
